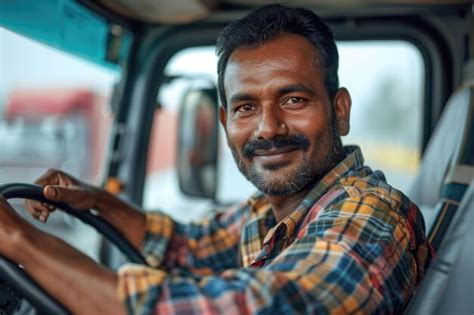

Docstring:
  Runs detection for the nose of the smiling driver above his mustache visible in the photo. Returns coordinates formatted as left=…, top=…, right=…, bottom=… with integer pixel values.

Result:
left=255, top=106, right=288, bottom=140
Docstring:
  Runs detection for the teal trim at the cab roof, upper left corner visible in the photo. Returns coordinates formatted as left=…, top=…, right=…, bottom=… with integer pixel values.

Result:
left=0, top=0, right=132, bottom=70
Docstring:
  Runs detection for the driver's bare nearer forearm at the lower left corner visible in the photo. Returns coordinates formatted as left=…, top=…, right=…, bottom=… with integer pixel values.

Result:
left=0, top=197, right=125, bottom=315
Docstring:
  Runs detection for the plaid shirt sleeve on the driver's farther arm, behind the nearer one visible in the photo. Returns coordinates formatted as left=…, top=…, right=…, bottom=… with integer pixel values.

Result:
left=141, top=203, right=249, bottom=274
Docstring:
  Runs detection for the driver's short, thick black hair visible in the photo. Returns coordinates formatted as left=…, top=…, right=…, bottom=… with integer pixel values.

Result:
left=216, top=4, right=339, bottom=107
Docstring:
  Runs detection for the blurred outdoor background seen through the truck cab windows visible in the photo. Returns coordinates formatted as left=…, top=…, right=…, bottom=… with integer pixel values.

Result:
left=0, top=28, right=425, bottom=257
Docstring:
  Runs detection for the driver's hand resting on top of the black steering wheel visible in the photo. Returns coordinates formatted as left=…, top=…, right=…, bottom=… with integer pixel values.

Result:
left=26, top=169, right=100, bottom=222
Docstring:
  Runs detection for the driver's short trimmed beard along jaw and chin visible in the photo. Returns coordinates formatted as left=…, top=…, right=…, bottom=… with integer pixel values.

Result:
left=229, top=119, right=344, bottom=196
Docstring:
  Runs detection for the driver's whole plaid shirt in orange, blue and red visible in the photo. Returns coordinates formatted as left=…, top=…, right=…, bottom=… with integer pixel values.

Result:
left=118, top=147, right=432, bottom=314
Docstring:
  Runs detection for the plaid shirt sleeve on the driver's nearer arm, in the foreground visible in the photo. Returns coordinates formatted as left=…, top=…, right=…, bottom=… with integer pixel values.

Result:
left=118, top=195, right=426, bottom=314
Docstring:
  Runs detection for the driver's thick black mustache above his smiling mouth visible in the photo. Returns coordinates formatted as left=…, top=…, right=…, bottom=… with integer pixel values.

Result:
left=243, top=134, right=310, bottom=158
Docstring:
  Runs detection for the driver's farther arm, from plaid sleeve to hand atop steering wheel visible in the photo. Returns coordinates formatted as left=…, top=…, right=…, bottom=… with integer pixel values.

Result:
left=27, top=170, right=246, bottom=273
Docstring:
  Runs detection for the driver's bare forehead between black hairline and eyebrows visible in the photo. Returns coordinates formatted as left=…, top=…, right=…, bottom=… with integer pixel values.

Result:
left=224, top=34, right=324, bottom=97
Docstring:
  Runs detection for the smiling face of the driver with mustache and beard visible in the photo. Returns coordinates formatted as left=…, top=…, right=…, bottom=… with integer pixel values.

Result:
left=220, top=34, right=350, bottom=195
